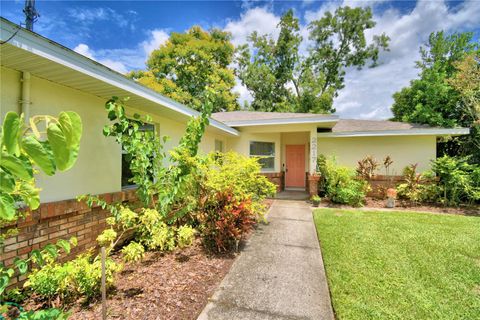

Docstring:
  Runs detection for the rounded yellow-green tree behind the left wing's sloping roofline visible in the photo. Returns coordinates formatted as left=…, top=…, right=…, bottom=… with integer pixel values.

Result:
left=129, top=26, right=239, bottom=112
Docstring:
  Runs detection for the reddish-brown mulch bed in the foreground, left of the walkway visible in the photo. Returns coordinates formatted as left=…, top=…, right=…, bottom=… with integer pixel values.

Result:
left=71, top=242, right=235, bottom=320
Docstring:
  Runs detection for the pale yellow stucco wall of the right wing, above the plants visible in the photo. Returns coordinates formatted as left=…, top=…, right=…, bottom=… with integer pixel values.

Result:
left=317, top=136, right=436, bottom=175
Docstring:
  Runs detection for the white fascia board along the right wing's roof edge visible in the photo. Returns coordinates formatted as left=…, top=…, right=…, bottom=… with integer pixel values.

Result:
left=317, top=128, right=470, bottom=138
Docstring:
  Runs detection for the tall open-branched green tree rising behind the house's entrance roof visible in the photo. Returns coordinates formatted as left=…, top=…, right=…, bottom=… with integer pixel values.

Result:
left=236, top=6, right=389, bottom=113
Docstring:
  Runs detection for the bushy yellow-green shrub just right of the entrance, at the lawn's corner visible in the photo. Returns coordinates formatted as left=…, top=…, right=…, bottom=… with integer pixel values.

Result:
left=321, top=159, right=368, bottom=206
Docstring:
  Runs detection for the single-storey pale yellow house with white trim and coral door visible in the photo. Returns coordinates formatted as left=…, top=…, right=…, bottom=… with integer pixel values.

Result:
left=0, top=18, right=468, bottom=203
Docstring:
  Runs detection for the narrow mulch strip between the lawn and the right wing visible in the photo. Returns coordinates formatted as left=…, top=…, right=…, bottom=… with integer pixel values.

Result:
left=320, top=197, right=480, bottom=216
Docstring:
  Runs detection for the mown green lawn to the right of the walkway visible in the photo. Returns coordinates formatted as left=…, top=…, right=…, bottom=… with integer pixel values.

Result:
left=314, top=209, right=480, bottom=320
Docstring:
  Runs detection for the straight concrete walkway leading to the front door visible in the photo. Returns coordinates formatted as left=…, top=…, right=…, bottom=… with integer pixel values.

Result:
left=198, top=200, right=334, bottom=320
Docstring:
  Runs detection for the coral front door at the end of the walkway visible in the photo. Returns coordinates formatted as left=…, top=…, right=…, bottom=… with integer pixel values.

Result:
left=285, top=145, right=305, bottom=188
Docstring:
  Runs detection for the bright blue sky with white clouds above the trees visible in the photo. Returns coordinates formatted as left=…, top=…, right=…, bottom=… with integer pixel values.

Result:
left=0, top=0, right=480, bottom=119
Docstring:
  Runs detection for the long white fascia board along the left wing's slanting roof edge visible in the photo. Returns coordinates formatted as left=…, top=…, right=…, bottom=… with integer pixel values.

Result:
left=0, top=18, right=239, bottom=136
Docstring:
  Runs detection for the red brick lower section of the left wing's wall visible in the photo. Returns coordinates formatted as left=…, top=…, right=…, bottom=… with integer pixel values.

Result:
left=0, top=190, right=136, bottom=284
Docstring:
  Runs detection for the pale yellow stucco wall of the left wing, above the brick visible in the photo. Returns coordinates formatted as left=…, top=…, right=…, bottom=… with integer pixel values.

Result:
left=0, top=68, right=226, bottom=202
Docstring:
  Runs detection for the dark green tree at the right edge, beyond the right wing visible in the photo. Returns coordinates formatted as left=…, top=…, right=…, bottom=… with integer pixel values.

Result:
left=392, top=31, right=480, bottom=162
